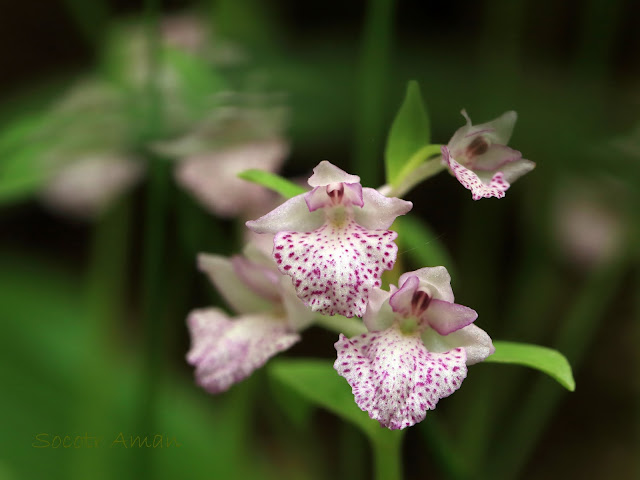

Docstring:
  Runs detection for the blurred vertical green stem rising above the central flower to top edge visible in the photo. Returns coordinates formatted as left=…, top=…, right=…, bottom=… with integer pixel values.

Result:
left=353, top=0, right=394, bottom=185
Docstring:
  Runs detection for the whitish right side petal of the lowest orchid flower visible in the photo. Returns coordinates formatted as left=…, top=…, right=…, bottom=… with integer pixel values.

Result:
left=422, top=324, right=495, bottom=365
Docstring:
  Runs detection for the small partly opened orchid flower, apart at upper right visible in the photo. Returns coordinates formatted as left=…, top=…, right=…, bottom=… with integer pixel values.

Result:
left=442, top=110, right=536, bottom=200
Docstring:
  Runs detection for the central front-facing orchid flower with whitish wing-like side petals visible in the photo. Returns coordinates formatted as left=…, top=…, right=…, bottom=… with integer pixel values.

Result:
left=247, top=161, right=412, bottom=317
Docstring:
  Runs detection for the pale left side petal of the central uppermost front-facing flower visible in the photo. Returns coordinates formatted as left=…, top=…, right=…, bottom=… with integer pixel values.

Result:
left=246, top=193, right=324, bottom=233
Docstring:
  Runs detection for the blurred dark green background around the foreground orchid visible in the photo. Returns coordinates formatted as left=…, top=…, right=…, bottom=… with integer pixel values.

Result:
left=0, top=0, right=640, bottom=480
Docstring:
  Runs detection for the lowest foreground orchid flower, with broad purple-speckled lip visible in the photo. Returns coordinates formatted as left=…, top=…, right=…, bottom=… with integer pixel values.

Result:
left=334, top=267, right=494, bottom=430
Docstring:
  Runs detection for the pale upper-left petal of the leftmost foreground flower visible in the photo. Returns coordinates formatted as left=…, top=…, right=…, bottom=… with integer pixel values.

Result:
left=198, top=253, right=273, bottom=314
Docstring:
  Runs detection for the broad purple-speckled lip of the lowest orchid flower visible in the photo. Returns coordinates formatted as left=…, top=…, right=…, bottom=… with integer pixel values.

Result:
left=334, top=328, right=467, bottom=430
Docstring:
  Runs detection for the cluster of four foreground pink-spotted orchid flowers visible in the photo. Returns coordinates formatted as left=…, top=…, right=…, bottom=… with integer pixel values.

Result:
left=187, top=111, right=535, bottom=429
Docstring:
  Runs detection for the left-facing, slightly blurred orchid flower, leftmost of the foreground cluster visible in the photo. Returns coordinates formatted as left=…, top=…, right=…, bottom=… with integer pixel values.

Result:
left=187, top=250, right=312, bottom=393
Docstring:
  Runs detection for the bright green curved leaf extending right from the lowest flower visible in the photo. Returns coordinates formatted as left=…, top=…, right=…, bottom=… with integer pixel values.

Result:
left=485, top=342, right=576, bottom=392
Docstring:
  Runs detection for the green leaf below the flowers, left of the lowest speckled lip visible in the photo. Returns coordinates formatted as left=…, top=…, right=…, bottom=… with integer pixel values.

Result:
left=269, top=359, right=397, bottom=442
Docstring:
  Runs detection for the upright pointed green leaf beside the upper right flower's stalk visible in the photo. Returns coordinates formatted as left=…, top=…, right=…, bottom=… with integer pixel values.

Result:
left=385, top=81, right=431, bottom=185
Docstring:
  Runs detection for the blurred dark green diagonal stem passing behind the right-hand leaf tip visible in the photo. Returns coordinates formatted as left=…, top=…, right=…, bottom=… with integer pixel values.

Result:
left=486, top=246, right=628, bottom=479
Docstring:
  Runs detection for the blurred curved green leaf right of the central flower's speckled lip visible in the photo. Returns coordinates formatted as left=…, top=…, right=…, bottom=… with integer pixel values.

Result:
left=393, top=215, right=456, bottom=278
